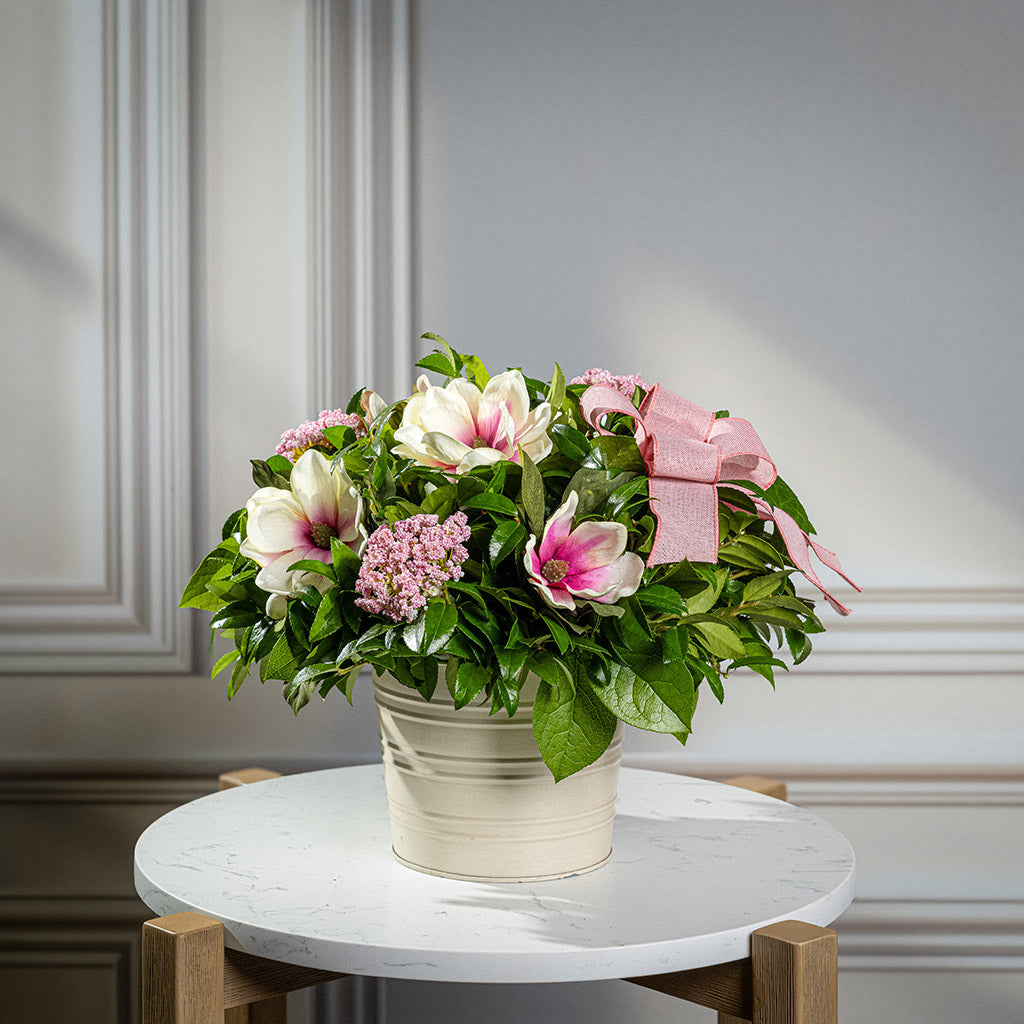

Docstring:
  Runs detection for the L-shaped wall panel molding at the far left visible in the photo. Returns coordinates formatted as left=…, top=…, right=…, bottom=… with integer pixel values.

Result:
left=0, top=0, right=193, bottom=674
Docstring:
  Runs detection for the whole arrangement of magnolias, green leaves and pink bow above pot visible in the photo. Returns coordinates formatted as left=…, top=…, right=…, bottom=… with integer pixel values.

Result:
left=181, top=334, right=849, bottom=779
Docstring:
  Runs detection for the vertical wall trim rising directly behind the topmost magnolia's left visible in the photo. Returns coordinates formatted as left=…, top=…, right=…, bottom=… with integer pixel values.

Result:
left=307, top=0, right=413, bottom=411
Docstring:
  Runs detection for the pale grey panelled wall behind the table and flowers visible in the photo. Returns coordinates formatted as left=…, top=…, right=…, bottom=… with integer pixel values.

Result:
left=0, top=0, right=1024, bottom=1024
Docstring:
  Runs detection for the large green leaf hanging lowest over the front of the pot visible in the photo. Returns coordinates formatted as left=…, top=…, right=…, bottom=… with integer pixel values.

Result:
left=534, top=679, right=615, bottom=782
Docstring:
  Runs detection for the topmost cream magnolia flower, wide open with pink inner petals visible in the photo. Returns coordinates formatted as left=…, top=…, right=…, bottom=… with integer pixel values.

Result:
left=394, top=370, right=551, bottom=473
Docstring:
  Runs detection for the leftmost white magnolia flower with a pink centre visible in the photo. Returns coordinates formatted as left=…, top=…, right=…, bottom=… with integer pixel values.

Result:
left=239, top=451, right=367, bottom=598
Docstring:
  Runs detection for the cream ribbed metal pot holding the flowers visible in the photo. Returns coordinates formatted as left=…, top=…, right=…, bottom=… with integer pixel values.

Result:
left=374, top=676, right=623, bottom=882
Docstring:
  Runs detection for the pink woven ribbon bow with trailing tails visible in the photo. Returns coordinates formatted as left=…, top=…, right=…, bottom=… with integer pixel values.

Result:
left=580, top=384, right=860, bottom=615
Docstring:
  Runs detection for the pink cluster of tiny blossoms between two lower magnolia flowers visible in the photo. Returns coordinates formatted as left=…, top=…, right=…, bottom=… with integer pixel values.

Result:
left=355, top=512, right=469, bottom=623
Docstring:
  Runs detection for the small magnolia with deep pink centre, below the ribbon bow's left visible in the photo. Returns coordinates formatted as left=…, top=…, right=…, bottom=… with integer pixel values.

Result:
left=523, top=490, right=644, bottom=611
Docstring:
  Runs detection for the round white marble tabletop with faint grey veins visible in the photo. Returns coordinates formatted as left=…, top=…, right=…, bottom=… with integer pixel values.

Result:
left=135, top=765, right=854, bottom=982
